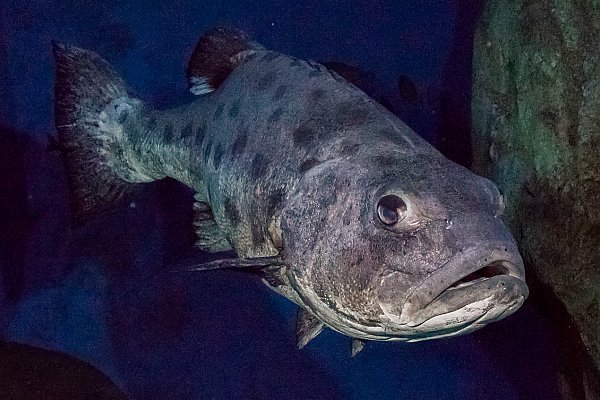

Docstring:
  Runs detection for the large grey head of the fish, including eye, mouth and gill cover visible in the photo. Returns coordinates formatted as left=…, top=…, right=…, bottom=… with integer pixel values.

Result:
left=282, top=155, right=528, bottom=341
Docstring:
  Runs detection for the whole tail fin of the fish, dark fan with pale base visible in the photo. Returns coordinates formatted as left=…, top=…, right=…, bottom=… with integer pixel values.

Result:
left=53, top=42, right=155, bottom=224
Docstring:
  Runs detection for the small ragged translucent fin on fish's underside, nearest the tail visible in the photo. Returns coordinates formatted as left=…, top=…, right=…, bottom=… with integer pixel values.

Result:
left=193, top=199, right=233, bottom=253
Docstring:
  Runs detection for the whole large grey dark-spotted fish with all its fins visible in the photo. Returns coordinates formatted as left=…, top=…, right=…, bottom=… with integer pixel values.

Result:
left=53, top=28, right=528, bottom=354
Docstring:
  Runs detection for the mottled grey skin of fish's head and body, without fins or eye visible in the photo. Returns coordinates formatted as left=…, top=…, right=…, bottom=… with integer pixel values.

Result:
left=52, top=30, right=527, bottom=344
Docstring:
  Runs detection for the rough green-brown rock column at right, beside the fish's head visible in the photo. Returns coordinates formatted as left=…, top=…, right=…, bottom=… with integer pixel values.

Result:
left=473, top=0, right=600, bottom=398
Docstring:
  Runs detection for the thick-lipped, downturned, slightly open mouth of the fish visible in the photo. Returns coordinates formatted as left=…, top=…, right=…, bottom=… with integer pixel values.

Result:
left=380, top=245, right=529, bottom=342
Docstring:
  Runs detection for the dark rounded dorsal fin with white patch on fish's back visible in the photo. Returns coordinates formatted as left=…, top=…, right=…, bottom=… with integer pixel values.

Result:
left=186, top=27, right=262, bottom=95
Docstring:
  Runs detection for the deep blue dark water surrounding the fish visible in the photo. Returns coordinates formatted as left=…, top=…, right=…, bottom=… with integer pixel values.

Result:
left=0, top=0, right=562, bottom=400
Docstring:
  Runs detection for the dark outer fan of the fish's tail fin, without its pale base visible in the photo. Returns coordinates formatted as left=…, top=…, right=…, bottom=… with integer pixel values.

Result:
left=52, top=42, right=135, bottom=224
